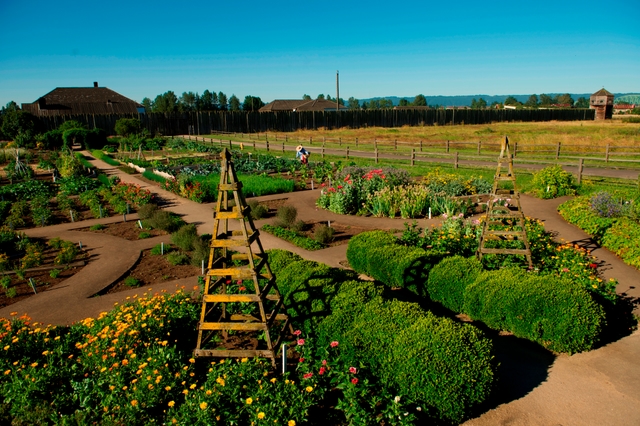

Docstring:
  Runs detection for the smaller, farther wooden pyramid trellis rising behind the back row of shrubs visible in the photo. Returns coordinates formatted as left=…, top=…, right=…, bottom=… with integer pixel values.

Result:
left=477, top=137, right=533, bottom=268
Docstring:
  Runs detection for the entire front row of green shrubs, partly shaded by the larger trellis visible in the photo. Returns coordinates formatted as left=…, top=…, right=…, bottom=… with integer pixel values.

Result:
left=269, top=250, right=496, bottom=423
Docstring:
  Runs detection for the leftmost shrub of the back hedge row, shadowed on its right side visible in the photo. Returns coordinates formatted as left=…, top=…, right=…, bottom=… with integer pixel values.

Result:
left=347, top=231, right=442, bottom=296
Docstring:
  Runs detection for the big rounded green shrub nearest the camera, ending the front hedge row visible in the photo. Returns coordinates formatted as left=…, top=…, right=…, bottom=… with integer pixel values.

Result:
left=319, top=296, right=495, bottom=422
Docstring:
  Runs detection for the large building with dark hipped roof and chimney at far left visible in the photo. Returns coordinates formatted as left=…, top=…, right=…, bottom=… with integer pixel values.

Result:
left=22, top=82, right=145, bottom=116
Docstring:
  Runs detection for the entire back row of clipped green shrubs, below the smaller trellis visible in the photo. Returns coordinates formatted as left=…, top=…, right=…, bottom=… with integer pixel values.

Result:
left=347, top=231, right=605, bottom=353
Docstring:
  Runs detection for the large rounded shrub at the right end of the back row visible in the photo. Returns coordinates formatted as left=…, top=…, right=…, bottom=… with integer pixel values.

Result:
left=464, top=268, right=605, bottom=353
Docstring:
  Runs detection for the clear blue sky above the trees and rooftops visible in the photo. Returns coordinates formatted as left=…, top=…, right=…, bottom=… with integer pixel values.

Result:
left=0, top=0, right=640, bottom=105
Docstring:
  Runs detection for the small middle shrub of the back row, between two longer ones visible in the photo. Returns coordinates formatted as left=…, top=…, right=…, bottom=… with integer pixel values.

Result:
left=427, top=256, right=482, bottom=312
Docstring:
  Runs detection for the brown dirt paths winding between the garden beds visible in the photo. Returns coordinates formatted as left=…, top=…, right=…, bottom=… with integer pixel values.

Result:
left=0, top=152, right=640, bottom=426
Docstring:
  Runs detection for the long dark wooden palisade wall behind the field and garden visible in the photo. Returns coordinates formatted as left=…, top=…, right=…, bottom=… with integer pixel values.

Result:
left=38, top=109, right=595, bottom=135
